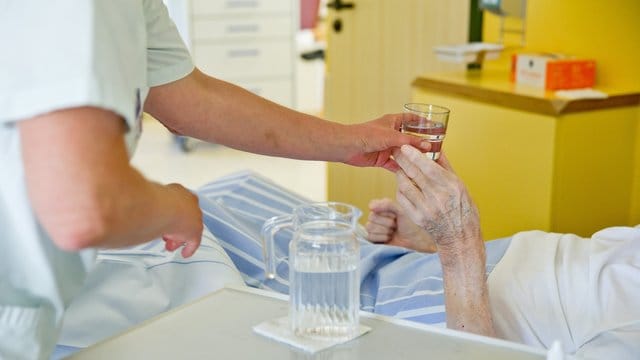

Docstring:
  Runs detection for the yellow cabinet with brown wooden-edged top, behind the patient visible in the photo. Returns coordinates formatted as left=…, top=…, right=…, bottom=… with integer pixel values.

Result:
left=413, top=71, right=640, bottom=239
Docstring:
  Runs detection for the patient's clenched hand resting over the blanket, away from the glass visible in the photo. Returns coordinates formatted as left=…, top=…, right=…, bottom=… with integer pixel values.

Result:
left=365, top=198, right=436, bottom=253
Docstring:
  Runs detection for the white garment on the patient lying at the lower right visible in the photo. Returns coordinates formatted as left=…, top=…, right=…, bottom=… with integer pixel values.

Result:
left=488, top=227, right=640, bottom=359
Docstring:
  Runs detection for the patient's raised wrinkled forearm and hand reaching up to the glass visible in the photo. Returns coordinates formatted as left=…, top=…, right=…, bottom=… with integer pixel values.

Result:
left=394, top=146, right=495, bottom=336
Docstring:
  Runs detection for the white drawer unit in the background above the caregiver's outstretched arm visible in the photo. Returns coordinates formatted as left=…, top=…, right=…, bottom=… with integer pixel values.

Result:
left=190, top=0, right=299, bottom=107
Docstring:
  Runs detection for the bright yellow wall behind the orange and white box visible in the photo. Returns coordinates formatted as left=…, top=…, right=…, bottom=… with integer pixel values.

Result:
left=483, top=0, right=640, bottom=91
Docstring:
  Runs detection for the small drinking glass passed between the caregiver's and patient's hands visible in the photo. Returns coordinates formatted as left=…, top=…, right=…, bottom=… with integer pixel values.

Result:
left=400, top=103, right=450, bottom=160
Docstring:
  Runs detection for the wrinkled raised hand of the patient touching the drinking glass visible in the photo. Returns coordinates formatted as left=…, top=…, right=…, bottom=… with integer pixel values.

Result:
left=394, top=146, right=482, bottom=252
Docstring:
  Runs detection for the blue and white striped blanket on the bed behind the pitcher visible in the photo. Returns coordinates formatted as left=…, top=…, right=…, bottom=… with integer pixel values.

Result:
left=198, top=172, right=510, bottom=326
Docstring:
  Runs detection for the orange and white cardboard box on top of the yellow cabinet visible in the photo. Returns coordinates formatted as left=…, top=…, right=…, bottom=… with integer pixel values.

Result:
left=511, top=54, right=596, bottom=90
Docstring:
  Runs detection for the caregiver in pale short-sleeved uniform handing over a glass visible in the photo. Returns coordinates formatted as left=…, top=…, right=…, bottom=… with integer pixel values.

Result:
left=0, top=0, right=428, bottom=359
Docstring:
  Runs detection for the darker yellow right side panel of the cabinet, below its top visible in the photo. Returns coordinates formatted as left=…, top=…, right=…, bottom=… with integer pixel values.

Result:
left=552, top=107, right=638, bottom=232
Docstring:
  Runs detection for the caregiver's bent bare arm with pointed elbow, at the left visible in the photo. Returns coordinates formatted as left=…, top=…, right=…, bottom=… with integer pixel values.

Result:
left=20, top=107, right=202, bottom=250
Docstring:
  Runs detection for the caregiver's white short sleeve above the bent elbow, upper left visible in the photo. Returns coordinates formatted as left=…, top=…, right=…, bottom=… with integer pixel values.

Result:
left=0, top=0, right=146, bottom=126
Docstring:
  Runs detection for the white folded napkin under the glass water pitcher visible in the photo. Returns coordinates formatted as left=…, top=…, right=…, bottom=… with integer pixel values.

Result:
left=253, top=316, right=371, bottom=354
